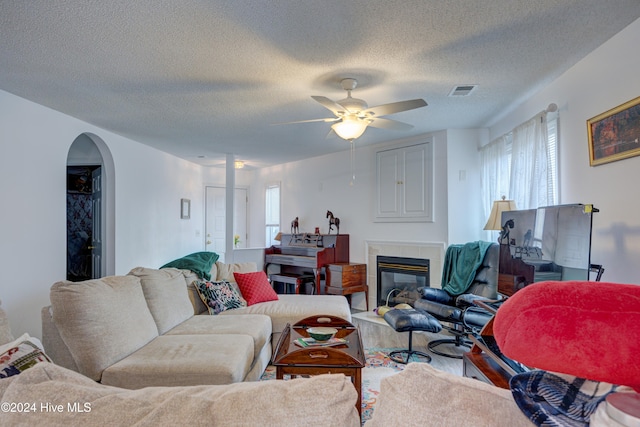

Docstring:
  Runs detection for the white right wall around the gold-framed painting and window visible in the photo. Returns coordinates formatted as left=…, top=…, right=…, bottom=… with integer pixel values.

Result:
left=484, top=20, right=640, bottom=283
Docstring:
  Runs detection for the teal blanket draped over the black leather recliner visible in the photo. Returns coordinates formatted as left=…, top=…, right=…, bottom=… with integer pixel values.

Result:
left=442, top=241, right=492, bottom=296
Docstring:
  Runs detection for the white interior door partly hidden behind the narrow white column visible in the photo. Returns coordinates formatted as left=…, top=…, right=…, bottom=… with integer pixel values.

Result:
left=205, top=186, right=249, bottom=262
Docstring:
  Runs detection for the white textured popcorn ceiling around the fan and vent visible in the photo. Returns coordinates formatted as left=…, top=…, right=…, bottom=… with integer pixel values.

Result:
left=0, top=0, right=640, bottom=167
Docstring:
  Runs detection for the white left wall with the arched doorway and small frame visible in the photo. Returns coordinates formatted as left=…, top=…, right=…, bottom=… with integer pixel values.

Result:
left=0, top=91, right=203, bottom=337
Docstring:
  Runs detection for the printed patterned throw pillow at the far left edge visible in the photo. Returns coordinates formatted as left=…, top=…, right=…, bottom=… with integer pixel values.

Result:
left=0, top=334, right=51, bottom=378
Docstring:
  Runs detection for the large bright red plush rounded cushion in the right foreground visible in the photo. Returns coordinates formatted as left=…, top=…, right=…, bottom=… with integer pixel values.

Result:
left=493, top=281, right=640, bottom=391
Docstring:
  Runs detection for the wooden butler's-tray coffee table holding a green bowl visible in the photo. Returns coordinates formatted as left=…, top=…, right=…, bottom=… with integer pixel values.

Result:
left=272, top=315, right=365, bottom=413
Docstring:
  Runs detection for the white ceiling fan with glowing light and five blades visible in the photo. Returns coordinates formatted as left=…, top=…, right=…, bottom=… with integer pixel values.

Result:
left=288, top=78, right=427, bottom=142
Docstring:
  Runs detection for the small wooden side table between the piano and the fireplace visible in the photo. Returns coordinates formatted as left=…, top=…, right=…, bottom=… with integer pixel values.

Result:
left=325, top=262, right=369, bottom=311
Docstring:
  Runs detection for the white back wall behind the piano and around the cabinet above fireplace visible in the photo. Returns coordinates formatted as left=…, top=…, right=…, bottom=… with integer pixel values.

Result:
left=252, top=132, right=456, bottom=263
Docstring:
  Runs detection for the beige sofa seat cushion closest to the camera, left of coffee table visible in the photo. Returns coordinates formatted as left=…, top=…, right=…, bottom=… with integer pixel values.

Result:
left=101, top=334, right=254, bottom=389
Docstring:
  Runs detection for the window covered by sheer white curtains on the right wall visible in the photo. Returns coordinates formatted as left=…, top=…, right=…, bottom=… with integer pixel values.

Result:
left=480, top=113, right=559, bottom=218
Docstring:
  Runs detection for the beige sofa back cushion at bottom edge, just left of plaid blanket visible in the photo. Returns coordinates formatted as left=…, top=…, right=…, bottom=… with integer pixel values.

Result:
left=365, top=363, right=532, bottom=427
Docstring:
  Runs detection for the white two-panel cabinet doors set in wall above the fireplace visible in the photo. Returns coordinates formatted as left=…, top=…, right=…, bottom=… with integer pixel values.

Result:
left=375, top=142, right=433, bottom=222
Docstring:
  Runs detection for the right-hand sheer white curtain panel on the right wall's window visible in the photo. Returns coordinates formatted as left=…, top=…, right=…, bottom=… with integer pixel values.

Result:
left=509, top=113, right=551, bottom=209
